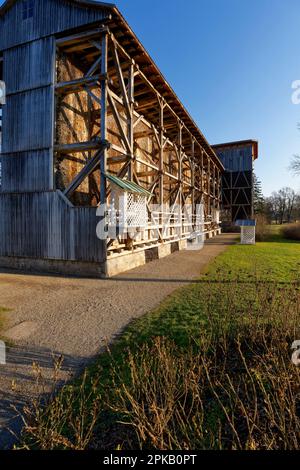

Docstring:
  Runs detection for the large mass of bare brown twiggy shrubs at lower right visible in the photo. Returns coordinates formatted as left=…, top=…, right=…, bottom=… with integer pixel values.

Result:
left=109, top=327, right=300, bottom=450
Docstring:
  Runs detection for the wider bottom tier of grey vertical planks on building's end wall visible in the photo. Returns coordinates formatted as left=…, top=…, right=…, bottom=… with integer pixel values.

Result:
left=0, top=191, right=104, bottom=262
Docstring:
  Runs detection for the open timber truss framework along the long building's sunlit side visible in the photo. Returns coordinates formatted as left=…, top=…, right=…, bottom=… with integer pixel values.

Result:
left=54, top=25, right=222, bottom=250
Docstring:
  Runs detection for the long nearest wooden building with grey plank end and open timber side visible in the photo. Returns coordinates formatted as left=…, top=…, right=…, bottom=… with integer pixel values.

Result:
left=0, top=0, right=224, bottom=275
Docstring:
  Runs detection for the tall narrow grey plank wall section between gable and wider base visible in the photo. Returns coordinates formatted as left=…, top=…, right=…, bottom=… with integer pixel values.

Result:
left=2, top=38, right=55, bottom=192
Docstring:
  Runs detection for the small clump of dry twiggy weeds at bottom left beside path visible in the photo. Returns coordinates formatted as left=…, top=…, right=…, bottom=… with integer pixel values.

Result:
left=18, top=363, right=100, bottom=450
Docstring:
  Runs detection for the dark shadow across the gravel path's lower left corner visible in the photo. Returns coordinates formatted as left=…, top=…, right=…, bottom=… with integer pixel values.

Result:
left=0, top=347, right=87, bottom=450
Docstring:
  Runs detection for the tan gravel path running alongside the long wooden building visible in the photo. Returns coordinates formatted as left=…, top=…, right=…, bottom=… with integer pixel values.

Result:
left=0, top=234, right=236, bottom=449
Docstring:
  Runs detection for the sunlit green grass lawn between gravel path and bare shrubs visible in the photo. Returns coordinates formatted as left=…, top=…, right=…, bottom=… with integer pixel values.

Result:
left=111, top=230, right=300, bottom=346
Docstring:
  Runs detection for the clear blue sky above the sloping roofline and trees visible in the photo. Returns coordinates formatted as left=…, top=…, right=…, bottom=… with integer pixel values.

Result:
left=0, top=0, right=300, bottom=195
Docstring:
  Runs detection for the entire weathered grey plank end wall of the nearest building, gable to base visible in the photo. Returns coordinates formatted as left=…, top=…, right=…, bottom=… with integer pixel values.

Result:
left=0, top=0, right=108, bottom=263
